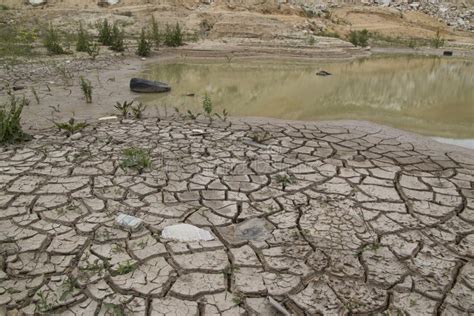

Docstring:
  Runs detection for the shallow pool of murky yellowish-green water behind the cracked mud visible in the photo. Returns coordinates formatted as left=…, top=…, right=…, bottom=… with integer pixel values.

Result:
left=143, top=56, right=474, bottom=139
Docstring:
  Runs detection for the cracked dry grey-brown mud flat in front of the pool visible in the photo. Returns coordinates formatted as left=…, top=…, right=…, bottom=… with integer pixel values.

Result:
left=0, top=119, right=474, bottom=315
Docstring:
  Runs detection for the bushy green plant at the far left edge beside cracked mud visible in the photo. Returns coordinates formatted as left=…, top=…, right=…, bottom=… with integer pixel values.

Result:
left=0, top=95, right=31, bottom=144
